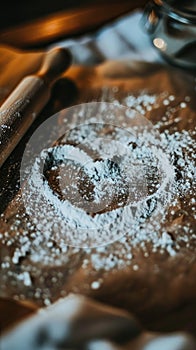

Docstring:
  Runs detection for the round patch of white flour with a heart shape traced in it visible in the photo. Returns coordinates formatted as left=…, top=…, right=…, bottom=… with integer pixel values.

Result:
left=20, top=105, right=172, bottom=248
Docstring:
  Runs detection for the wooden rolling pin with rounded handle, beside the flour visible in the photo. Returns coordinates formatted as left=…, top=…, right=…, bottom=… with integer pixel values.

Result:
left=0, top=48, right=71, bottom=167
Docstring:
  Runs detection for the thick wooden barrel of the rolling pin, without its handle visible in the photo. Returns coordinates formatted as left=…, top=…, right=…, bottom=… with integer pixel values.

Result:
left=0, top=76, right=50, bottom=167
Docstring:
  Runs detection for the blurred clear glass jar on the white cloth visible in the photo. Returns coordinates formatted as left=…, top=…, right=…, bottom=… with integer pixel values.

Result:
left=143, top=0, right=196, bottom=69
